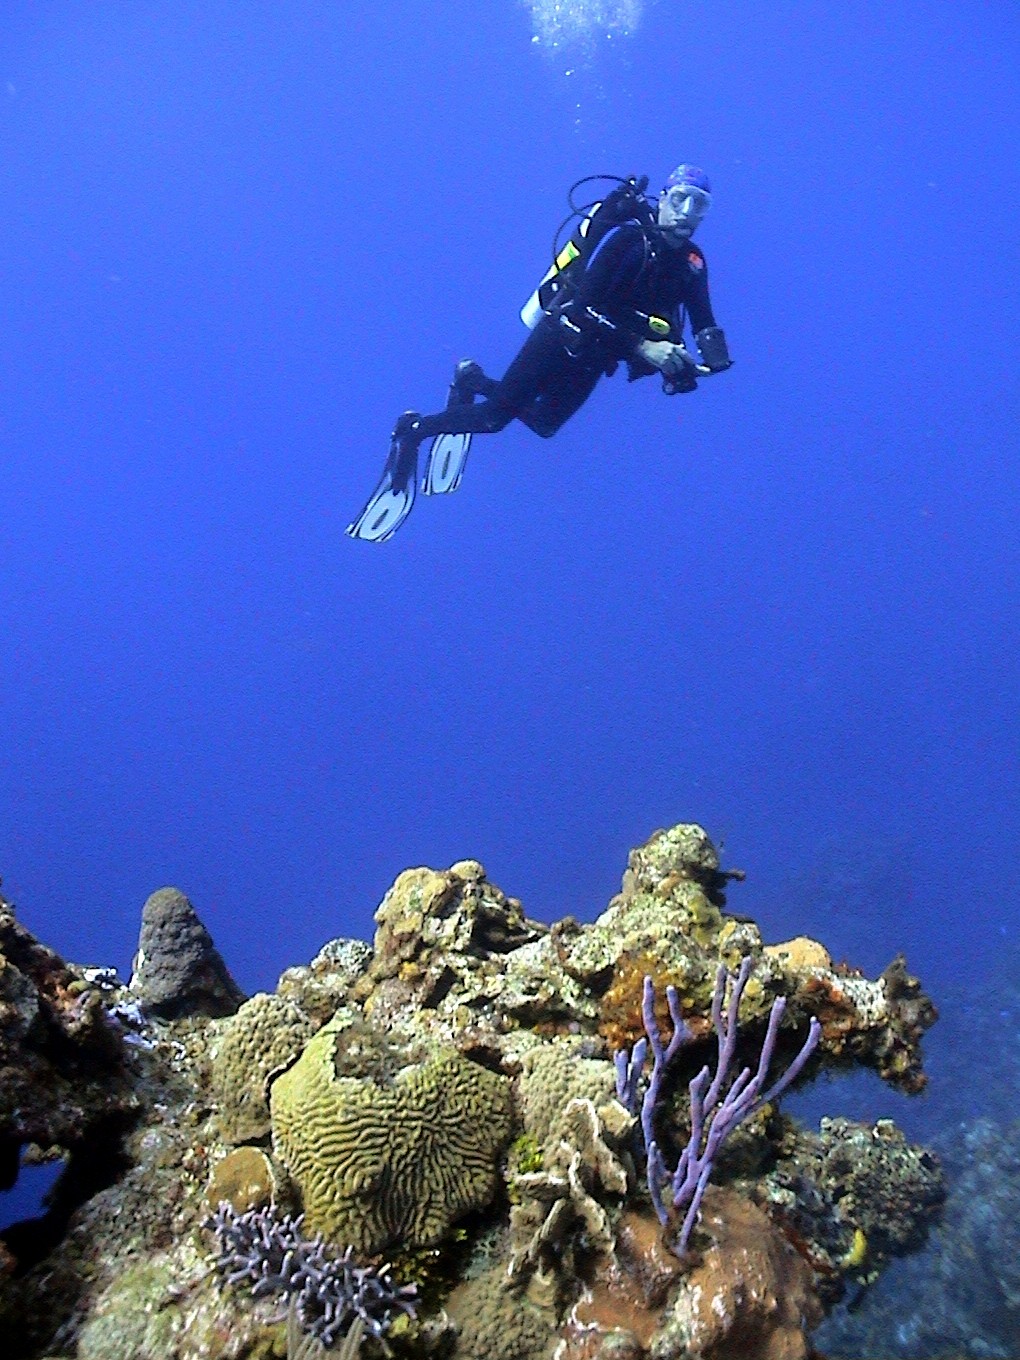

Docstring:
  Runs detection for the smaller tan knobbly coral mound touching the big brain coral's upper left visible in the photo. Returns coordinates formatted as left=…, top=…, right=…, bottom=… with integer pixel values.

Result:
left=211, top=991, right=314, bottom=1142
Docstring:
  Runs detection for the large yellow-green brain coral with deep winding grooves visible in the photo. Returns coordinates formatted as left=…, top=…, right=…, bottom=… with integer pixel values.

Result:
left=271, top=1025, right=511, bottom=1254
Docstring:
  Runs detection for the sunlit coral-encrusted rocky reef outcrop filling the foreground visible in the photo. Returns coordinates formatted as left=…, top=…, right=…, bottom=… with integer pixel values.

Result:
left=0, top=824, right=944, bottom=1360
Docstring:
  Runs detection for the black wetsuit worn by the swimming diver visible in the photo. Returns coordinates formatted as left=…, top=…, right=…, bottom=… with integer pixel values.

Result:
left=415, top=223, right=715, bottom=441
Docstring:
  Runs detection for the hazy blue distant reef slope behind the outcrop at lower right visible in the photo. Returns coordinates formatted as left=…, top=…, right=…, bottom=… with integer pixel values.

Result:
left=817, top=952, right=1020, bottom=1360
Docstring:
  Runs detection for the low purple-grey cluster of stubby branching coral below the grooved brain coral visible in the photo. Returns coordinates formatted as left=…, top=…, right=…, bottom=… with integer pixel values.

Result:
left=205, top=1201, right=418, bottom=1349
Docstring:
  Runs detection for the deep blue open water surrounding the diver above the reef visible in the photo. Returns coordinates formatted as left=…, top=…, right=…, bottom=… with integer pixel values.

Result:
left=0, top=0, right=1020, bottom=1011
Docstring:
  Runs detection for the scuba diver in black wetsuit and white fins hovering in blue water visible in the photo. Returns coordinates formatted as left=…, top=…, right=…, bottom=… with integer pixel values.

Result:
left=347, top=165, right=732, bottom=543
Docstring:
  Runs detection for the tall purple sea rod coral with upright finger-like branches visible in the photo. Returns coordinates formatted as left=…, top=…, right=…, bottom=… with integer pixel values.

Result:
left=615, top=957, right=821, bottom=1257
